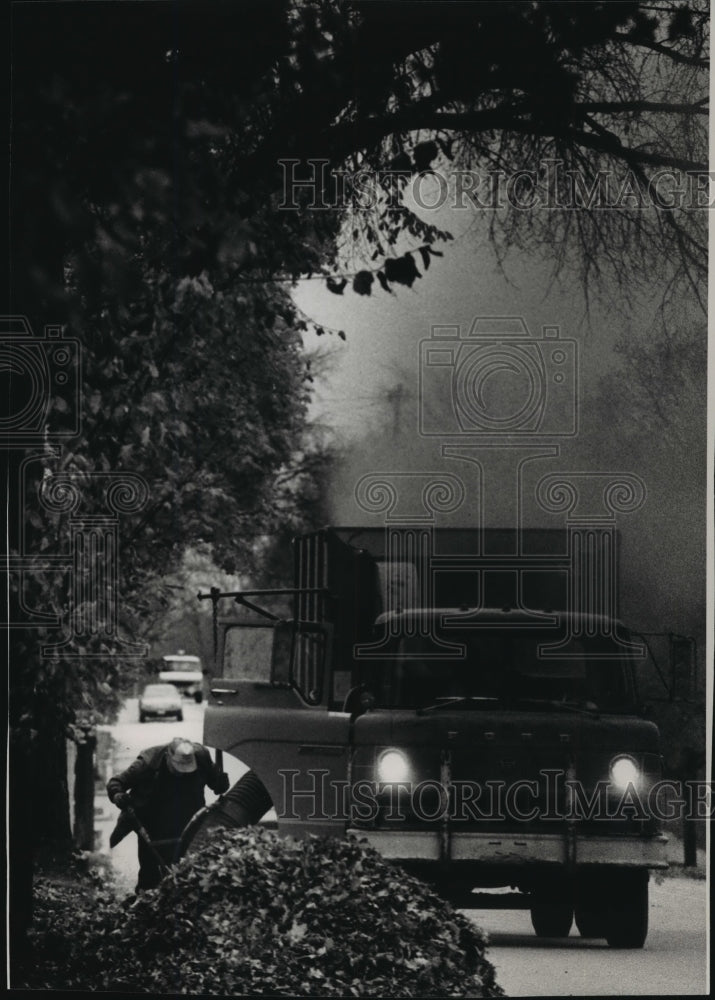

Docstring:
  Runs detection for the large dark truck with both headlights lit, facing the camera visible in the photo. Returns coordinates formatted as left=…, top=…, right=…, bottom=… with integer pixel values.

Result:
left=187, top=526, right=692, bottom=948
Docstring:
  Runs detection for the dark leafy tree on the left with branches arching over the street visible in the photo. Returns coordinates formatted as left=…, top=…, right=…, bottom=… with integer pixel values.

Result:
left=7, top=0, right=707, bottom=964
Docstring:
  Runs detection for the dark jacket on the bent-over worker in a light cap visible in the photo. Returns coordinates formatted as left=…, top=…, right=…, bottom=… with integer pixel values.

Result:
left=107, top=743, right=228, bottom=847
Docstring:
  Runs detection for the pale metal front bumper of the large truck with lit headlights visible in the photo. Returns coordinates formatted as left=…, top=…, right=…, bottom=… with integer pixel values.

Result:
left=347, top=829, right=668, bottom=868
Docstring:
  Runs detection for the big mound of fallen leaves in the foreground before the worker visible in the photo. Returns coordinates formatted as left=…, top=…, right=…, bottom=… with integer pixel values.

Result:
left=23, top=828, right=502, bottom=997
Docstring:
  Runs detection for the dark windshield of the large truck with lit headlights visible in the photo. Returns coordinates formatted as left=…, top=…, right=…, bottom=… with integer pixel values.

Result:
left=376, top=627, right=635, bottom=712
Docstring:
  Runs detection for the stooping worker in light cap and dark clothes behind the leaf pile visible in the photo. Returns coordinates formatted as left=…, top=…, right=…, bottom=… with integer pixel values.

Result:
left=107, top=737, right=229, bottom=892
